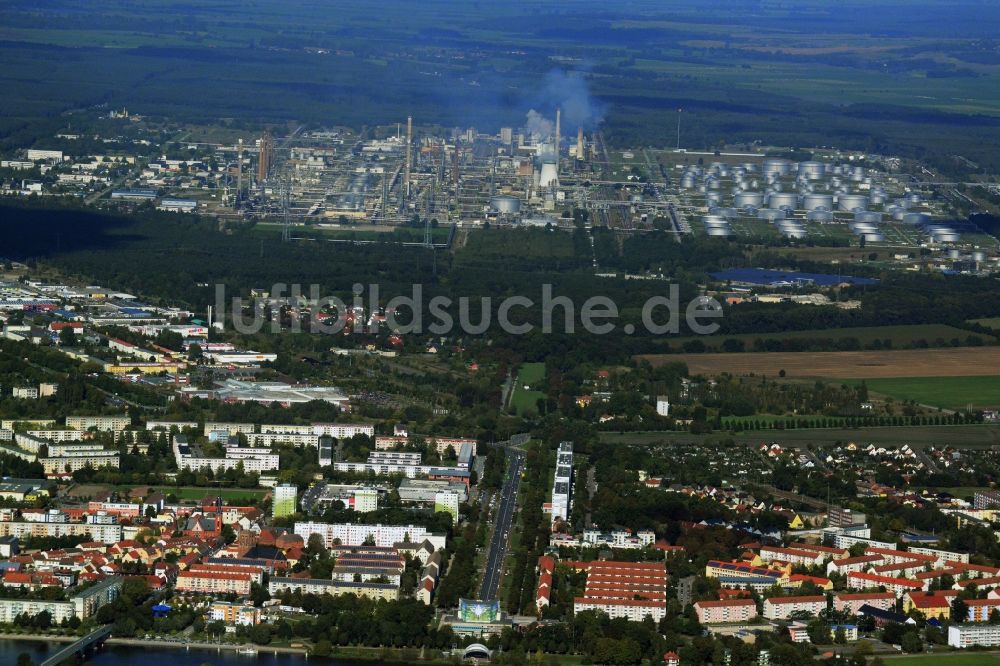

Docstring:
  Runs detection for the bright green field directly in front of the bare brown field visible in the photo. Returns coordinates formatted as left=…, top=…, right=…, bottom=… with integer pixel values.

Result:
left=845, top=375, right=1000, bottom=409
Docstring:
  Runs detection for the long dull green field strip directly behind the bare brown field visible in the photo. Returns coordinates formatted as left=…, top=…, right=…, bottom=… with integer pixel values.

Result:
left=667, top=320, right=984, bottom=349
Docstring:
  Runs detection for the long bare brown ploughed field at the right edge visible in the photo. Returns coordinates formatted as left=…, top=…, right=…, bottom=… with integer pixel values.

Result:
left=637, top=347, right=1000, bottom=380
